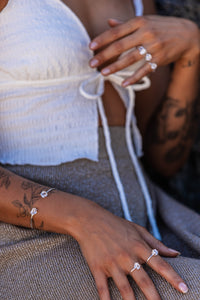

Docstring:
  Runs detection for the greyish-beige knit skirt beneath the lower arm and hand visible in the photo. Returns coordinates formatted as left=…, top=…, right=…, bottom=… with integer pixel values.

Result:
left=0, top=127, right=200, bottom=300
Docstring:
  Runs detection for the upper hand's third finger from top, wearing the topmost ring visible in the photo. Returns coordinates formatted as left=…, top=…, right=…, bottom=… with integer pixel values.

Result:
left=101, top=49, right=142, bottom=75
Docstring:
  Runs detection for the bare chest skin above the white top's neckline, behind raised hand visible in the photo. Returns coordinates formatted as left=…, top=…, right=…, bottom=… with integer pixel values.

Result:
left=62, top=0, right=134, bottom=38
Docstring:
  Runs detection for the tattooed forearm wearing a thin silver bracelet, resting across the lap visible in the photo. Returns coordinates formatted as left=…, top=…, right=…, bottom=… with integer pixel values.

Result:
left=0, top=168, right=95, bottom=239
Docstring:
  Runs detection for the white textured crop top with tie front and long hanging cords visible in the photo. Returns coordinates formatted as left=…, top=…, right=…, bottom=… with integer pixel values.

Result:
left=0, top=0, right=159, bottom=238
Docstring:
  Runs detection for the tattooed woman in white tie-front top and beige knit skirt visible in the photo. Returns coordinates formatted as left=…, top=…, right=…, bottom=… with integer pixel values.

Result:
left=0, top=0, right=200, bottom=300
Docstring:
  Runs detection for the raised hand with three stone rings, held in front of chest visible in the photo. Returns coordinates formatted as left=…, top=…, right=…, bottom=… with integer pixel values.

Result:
left=89, top=15, right=199, bottom=86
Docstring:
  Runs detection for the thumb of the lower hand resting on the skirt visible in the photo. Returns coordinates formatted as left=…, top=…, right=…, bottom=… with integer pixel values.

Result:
left=136, top=225, right=180, bottom=257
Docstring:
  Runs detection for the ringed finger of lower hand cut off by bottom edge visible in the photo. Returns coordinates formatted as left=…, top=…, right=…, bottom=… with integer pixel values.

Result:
left=130, top=267, right=161, bottom=300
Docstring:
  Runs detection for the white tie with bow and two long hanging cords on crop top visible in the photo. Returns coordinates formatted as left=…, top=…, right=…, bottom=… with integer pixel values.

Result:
left=79, top=71, right=161, bottom=240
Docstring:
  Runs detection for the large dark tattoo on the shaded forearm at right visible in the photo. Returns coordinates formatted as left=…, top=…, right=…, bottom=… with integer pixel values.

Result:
left=150, top=97, right=195, bottom=163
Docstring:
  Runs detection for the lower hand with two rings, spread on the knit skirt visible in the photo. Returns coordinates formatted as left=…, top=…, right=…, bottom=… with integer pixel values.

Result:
left=72, top=203, right=187, bottom=300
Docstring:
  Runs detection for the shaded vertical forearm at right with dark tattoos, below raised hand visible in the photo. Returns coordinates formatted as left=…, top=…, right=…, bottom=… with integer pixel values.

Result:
left=144, top=39, right=199, bottom=176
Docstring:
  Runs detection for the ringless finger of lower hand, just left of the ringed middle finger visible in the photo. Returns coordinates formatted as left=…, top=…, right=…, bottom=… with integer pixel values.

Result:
left=112, top=270, right=136, bottom=300
